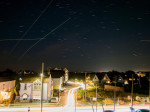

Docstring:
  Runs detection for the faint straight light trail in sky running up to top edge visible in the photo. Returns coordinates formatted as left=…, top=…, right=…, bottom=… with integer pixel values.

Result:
left=9, top=0, right=53, bottom=54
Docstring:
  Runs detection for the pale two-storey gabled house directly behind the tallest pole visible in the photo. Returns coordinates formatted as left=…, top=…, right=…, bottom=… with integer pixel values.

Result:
left=20, top=76, right=53, bottom=102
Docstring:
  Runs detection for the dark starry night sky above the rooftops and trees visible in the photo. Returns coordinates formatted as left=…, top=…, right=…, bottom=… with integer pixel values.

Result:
left=0, top=0, right=150, bottom=72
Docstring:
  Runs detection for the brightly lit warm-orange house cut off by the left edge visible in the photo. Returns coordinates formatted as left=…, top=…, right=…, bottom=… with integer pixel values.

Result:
left=0, top=77, right=16, bottom=103
